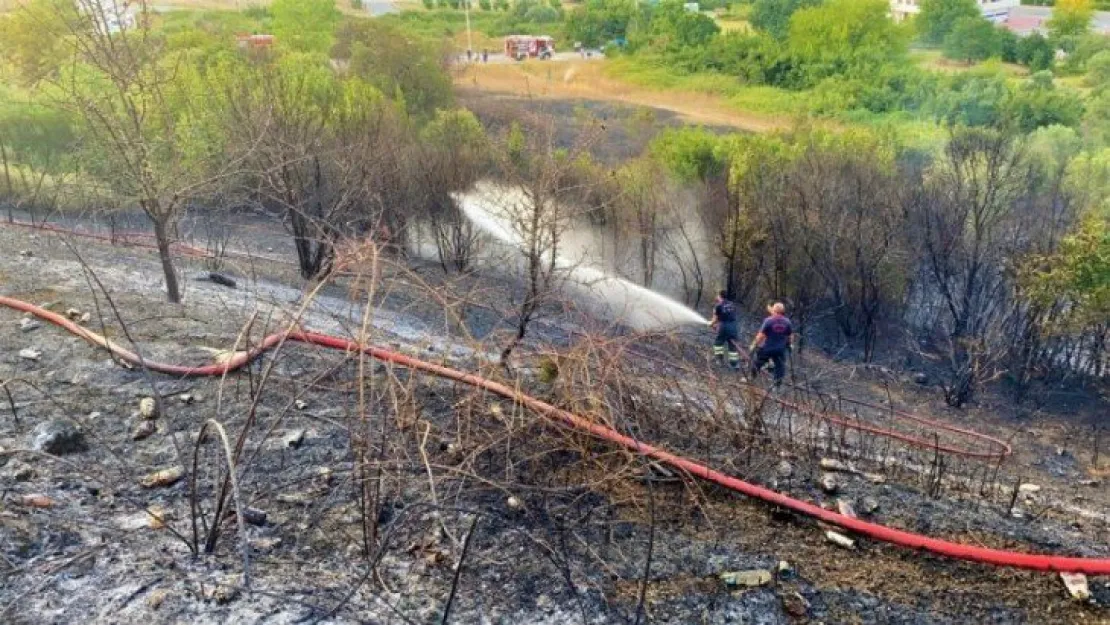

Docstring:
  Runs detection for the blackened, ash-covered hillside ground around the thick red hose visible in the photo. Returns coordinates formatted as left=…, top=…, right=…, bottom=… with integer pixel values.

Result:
left=0, top=222, right=1110, bottom=625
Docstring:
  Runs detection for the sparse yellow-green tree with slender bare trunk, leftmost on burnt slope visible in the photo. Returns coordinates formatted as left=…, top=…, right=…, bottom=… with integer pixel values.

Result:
left=4, top=0, right=234, bottom=303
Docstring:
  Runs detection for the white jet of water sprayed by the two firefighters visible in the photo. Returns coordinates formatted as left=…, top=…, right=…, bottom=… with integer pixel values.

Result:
left=455, top=183, right=707, bottom=330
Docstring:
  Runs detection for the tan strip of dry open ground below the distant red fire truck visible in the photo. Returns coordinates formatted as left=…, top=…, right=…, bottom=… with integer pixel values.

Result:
left=455, top=60, right=791, bottom=132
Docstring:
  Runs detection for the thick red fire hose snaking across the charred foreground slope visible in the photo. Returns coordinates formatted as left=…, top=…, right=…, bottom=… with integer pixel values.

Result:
left=0, top=296, right=1110, bottom=575
